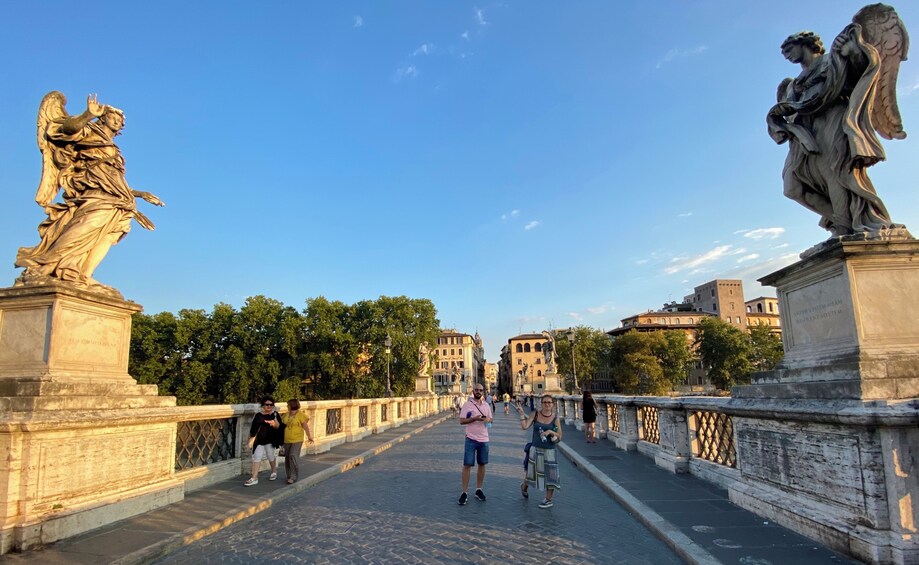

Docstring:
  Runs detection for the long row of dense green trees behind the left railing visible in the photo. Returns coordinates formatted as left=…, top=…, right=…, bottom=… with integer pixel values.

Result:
left=129, top=296, right=439, bottom=405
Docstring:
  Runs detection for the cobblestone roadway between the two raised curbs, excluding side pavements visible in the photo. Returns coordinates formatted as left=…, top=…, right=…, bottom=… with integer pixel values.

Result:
left=158, top=410, right=681, bottom=565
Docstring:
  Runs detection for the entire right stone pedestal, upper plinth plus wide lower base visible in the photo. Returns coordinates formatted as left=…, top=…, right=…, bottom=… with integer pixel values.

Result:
left=729, top=234, right=919, bottom=563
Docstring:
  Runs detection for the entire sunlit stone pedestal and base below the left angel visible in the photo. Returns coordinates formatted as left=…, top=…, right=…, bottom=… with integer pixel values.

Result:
left=0, top=285, right=184, bottom=553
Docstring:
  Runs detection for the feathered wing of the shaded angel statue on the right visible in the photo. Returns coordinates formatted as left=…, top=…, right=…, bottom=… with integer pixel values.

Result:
left=852, top=4, right=909, bottom=139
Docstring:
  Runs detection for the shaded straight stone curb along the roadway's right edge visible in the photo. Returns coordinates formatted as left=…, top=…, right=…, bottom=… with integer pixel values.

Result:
left=558, top=443, right=721, bottom=565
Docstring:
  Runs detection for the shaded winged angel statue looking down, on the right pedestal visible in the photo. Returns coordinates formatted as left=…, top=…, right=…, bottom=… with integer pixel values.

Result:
left=767, top=4, right=909, bottom=236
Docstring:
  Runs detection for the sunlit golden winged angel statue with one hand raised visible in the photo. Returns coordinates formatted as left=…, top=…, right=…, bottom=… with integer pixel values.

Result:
left=16, top=91, right=163, bottom=296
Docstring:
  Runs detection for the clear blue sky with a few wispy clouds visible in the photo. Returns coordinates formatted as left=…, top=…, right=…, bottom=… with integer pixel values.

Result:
left=0, top=0, right=919, bottom=361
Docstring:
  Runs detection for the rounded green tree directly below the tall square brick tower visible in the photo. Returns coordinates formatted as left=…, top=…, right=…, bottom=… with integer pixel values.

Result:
left=697, top=316, right=753, bottom=390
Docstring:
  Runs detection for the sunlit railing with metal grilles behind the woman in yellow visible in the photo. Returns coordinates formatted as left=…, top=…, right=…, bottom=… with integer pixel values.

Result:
left=172, top=396, right=452, bottom=492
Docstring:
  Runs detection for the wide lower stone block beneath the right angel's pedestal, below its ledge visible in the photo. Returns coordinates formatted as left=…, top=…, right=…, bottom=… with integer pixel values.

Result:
left=728, top=399, right=919, bottom=564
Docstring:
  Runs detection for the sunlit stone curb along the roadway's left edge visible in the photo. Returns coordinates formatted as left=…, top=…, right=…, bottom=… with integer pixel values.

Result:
left=110, top=413, right=452, bottom=565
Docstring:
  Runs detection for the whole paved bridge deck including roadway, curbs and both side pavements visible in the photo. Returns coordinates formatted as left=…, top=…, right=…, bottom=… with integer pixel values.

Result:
left=4, top=407, right=856, bottom=565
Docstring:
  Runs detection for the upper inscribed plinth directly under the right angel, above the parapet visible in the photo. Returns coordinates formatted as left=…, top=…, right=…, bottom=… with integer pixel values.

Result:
left=733, top=231, right=919, bottom=400
